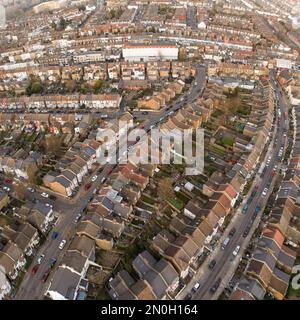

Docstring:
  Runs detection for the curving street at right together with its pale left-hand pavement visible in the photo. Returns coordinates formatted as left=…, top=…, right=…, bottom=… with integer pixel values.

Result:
left=177, top=71, right=288, bottom=300
